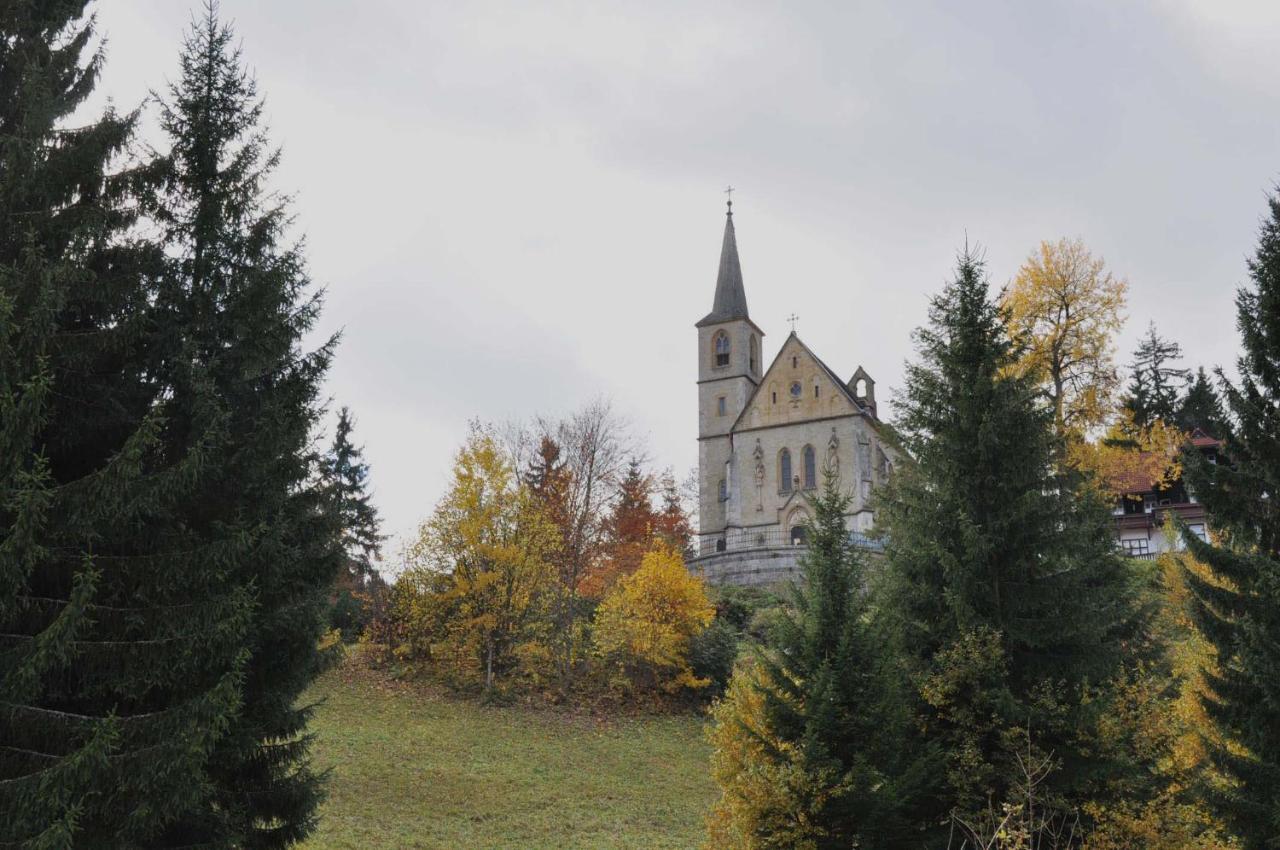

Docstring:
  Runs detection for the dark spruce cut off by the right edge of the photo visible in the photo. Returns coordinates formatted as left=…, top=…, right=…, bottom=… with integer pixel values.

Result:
left=1184, top=193, right=1280, bottom=850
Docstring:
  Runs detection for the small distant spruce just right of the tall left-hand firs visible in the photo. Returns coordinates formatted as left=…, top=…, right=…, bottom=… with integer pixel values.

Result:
left=324, top=407, right=387, bottom=586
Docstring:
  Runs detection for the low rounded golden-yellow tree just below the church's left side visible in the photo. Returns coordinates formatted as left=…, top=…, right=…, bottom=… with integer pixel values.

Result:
left=594, top=543, right=716, bottom=693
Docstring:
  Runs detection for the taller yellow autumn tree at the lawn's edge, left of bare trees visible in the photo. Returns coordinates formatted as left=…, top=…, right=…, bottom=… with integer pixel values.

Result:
left=397, top=425, right=557, bottom=690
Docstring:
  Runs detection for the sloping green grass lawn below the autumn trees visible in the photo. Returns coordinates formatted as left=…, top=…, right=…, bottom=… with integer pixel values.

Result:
left=305, top=662, right=716, bottom=850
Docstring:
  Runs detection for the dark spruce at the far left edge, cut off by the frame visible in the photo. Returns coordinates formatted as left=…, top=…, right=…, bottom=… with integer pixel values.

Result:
left=0, top=0, right=248, bottom=849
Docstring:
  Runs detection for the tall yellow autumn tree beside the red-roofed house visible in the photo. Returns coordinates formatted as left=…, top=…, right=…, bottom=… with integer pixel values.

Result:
left=1001, top=239, right=1129, bottom=435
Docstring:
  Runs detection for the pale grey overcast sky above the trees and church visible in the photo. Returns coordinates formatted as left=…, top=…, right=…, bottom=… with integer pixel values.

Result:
left=90, top=0, right=1280, bottom=555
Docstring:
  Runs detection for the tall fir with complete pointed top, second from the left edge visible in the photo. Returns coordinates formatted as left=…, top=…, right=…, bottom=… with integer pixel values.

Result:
left=148, top=3, right=346, bottom=847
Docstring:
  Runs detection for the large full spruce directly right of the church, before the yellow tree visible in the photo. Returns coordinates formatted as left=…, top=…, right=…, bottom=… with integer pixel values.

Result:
left=877, top=251, right=1132, bottom=846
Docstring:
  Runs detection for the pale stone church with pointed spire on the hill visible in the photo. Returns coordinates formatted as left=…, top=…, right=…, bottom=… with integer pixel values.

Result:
left=690, top=201, right=893, bottom=585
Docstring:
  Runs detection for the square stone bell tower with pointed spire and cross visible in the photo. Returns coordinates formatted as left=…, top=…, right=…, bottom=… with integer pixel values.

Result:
left=695, top=200, right=764, bottom=550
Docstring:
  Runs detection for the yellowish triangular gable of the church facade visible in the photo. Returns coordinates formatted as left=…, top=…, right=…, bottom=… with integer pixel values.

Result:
left=733, top=333, right=860, bottom=431
